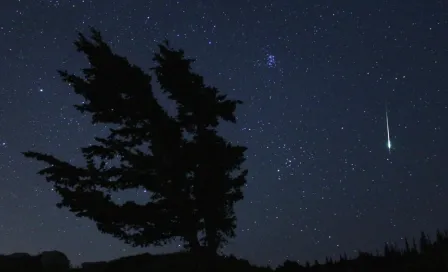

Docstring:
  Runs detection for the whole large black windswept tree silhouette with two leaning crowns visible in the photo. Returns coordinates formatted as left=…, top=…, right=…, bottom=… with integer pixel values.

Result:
left=24, top=28, right=247, bottom=264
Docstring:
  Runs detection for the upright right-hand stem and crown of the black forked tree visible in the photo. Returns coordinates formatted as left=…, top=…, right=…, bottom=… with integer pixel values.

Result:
left=154, top=41, right=247, bottom=258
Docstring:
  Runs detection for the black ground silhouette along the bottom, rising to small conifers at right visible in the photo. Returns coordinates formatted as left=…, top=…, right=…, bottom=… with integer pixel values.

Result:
left=0, top=231, right=448, bottom=272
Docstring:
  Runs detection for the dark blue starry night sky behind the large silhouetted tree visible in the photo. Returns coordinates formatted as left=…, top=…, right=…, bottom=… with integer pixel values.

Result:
left=0, top=0, right=448, bottom=266
